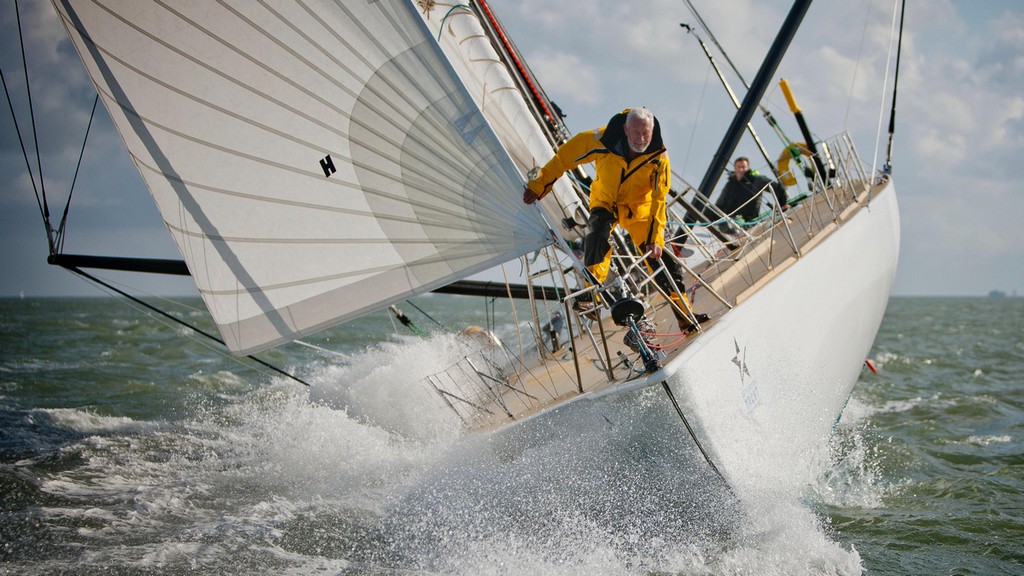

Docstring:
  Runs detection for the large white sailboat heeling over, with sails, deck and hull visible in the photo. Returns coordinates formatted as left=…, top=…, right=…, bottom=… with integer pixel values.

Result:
left=19, top=0, right=899, bottom=494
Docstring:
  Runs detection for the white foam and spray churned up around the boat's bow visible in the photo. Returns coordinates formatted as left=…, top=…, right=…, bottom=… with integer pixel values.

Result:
left=6, top=327, right=888, bottom=575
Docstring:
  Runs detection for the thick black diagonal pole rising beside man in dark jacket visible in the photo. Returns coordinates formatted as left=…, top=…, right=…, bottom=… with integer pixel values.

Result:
left=698, top=0, right=811, bottom=198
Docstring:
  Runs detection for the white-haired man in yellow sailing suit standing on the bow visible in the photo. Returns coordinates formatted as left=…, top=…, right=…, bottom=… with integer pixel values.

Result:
left=522, top=108, right=707, bottom=331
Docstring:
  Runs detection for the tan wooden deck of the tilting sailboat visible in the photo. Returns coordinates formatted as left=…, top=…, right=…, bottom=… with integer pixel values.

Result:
left=429, top=171, right=883, bottom=430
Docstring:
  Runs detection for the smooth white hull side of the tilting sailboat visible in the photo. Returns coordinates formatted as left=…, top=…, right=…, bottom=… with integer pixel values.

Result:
left=589, top=178, right=899, bottom=493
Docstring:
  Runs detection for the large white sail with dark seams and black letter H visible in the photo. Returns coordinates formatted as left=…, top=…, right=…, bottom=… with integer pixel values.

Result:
left=54, top=0, right=551, bottom=353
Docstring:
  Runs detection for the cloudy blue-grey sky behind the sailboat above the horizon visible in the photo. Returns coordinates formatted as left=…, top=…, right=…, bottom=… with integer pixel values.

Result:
left=0, top=0, right=1024, bottom=296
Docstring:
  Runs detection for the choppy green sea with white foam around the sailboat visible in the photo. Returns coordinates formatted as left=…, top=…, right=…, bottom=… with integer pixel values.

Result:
left=0, top=296, right=1024, bottom=575
